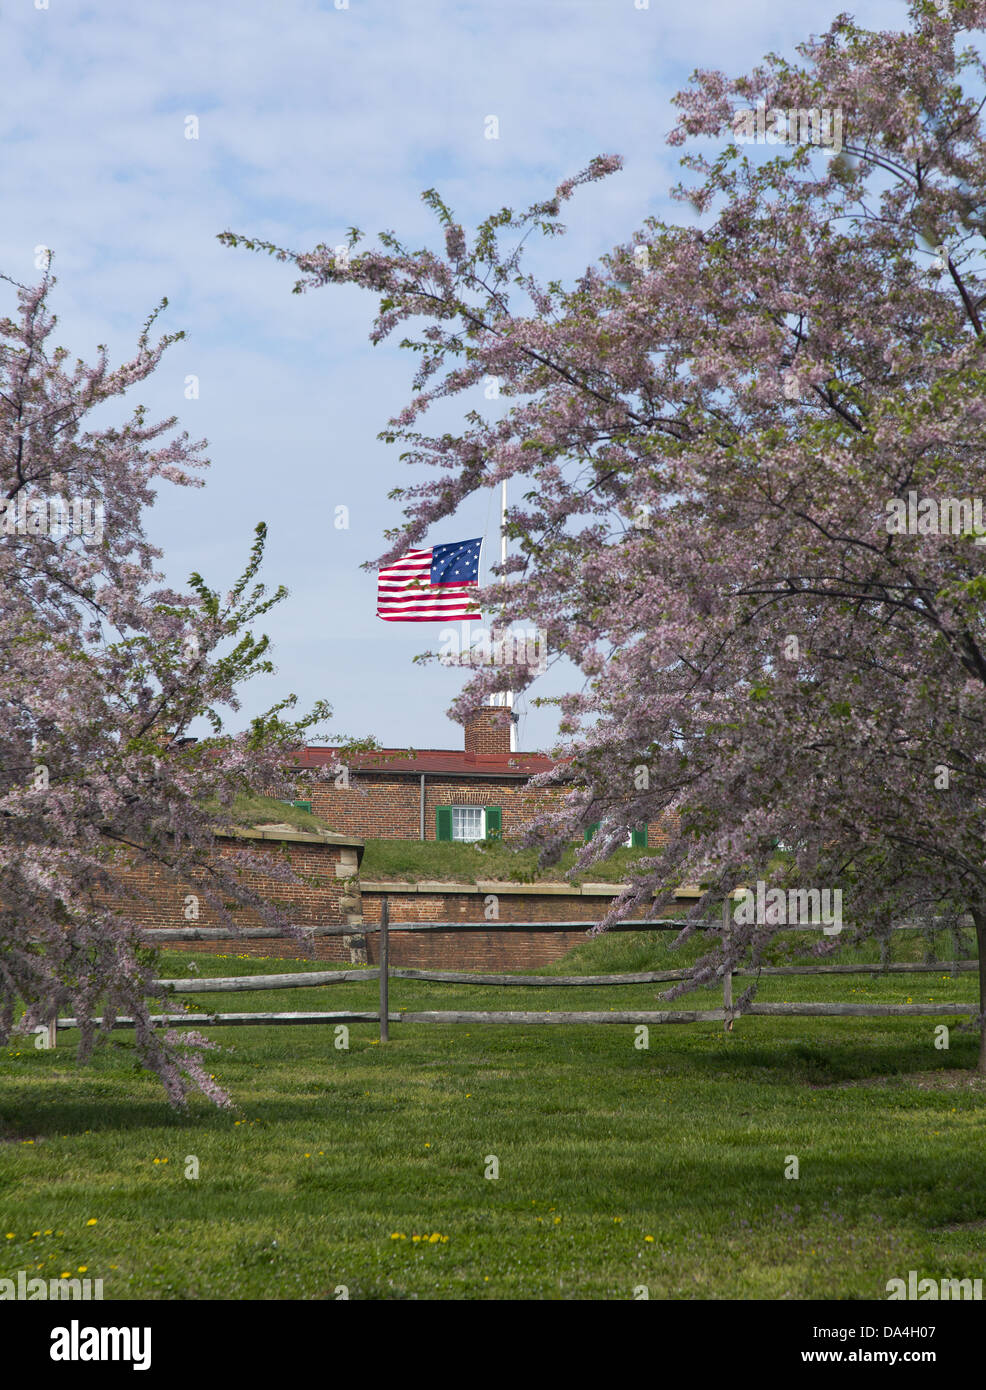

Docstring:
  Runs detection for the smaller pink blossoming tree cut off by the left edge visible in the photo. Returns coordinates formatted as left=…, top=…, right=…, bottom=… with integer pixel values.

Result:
left=0, top=270, right=335, bottom=1104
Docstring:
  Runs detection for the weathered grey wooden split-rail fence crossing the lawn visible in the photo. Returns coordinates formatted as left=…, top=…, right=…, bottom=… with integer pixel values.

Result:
left=49, top=898, right=979, bottom=1043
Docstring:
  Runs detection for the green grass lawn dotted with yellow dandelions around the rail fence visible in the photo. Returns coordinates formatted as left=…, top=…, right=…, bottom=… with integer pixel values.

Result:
left=0, top=933, right=986, bottom=1300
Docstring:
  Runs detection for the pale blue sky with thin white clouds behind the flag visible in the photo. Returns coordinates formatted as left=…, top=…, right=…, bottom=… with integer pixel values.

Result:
left=0, top=0, right=905, bottom=749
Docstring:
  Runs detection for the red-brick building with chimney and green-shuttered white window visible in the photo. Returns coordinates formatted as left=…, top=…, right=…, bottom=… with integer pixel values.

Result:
left=298, top=706, right=661, bottom=845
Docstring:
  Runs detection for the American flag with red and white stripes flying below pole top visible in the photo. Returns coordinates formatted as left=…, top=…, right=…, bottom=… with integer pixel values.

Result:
left=377, top=537, right=483, bottom=623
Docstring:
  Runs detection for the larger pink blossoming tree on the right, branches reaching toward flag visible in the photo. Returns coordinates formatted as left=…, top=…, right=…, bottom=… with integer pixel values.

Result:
left=223, top=0, right=986, bottom=1070
